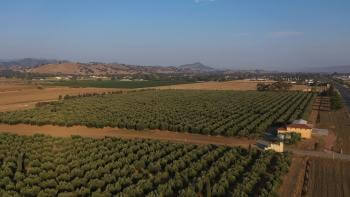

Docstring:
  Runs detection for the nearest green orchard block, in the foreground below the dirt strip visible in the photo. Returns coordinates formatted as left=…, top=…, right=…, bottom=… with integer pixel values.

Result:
left=0, top=133, right=291, bottom=197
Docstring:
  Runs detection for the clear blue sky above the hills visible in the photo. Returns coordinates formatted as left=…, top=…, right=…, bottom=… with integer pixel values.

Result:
left=0, top=0, right=350, bottom=70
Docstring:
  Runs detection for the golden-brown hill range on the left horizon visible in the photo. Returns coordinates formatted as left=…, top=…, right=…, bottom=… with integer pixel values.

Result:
left=0, top=58, right=217, bottom=75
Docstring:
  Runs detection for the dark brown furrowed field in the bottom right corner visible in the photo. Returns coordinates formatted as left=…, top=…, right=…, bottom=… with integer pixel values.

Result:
left=305, top=158, right=350, bottom=197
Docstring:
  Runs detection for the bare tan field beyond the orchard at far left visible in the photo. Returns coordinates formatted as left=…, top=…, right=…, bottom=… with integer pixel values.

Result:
left=0, top=79, right=121, bottom=112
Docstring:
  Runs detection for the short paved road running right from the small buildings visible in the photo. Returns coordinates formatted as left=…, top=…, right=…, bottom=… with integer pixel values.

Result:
left=285, top=148, right=350, bottom=161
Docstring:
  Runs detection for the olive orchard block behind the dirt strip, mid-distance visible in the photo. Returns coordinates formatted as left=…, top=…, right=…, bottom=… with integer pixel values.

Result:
left=0, top=90, right=314, bottom=137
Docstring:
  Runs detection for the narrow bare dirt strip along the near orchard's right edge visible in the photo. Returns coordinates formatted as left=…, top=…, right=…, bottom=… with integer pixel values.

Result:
left=278, top=156, right=306, bottom=197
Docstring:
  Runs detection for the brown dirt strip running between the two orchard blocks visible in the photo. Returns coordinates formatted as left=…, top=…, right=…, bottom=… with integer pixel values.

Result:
left=0, top=124, right=255, bottom=147
